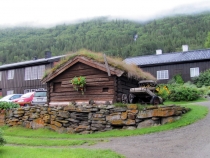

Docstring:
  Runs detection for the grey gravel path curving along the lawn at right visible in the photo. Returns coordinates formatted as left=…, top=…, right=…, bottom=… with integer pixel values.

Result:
left=83, top=101, right=210, bottom=158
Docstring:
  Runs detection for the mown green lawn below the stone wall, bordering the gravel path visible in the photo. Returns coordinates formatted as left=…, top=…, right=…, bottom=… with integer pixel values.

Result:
left=0, top=102, right=208, bottom=158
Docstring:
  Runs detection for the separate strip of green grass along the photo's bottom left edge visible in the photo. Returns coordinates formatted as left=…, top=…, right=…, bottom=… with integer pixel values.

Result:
left=0, top=146, right=124, bottom=158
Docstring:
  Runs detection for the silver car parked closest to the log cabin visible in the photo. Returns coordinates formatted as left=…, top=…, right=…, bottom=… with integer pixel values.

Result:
left=31, top=90, right=47, bottom=105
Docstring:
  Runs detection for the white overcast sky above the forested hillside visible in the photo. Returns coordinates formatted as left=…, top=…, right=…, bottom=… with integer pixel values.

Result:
left=0, top=0, right=210, bottom=27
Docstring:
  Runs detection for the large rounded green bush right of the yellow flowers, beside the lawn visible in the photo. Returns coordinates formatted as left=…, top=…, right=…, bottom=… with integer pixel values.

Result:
left=168, top=86, right=200, bottom=101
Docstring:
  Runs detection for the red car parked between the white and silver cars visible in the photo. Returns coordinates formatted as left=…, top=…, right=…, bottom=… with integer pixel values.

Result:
left=12, top=92, right=34, bottom=106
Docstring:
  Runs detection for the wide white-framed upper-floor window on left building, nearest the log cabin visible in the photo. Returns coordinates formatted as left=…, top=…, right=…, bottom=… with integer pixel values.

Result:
left=25, top=65, right=45, bottom=80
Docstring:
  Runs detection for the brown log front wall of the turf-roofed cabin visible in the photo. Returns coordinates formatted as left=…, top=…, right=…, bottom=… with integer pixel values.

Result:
left=49, top=63, right=116, bottom=102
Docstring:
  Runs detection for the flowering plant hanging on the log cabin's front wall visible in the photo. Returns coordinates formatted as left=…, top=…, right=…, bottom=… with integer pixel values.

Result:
left=70, top=76, right=86, bottom=94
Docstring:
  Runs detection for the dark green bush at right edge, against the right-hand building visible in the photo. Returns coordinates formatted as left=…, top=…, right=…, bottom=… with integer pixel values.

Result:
left=193, top=69, right=210, bottom=88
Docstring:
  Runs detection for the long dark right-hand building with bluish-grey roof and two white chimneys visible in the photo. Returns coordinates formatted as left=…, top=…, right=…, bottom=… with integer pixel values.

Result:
left=124, top=45, right=210, bottom=83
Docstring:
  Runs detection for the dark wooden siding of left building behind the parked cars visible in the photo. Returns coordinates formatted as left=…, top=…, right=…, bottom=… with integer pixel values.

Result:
left=0, top=63, right=51, bottom=96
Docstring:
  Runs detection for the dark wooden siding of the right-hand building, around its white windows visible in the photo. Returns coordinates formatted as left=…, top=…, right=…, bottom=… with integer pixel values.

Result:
left=141, top=61, right=210, bottom=83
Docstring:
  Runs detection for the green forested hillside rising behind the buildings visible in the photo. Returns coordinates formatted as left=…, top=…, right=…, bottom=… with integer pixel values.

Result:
left=0, top=13, right=210, bottom=64
